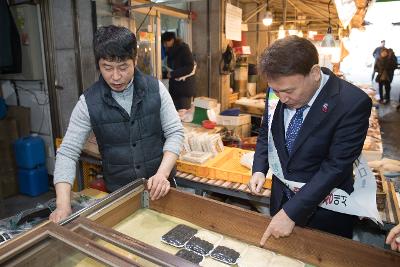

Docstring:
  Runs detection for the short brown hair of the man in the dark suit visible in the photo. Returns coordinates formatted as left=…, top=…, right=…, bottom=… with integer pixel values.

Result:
left=259, top=36, right=319, bottom=80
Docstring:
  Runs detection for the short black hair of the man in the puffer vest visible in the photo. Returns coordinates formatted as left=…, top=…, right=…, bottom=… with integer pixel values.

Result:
left=93, top=25, right=137, bottom=67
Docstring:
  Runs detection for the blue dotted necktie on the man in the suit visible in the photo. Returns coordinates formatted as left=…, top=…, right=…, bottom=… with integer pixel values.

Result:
left=283, top=105, right=308, bottom=199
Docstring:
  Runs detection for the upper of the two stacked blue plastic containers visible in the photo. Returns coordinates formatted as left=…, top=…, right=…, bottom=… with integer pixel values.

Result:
left=14, top=136, right=46, bottom=169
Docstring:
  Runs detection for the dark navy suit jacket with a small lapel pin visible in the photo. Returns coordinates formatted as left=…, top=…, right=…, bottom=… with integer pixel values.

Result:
left=253, top=68, right=372, bottom=237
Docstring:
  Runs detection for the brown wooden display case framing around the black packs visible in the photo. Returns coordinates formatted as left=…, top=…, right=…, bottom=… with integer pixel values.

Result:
left=0, top=180, right=400, bottom=266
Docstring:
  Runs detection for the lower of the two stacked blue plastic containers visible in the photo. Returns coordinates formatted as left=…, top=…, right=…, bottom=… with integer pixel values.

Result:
left=18, top=166, right=49, bottom=197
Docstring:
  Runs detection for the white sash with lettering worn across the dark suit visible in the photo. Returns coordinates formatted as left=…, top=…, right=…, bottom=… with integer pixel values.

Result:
left=267, top=100, right=383, bottom=224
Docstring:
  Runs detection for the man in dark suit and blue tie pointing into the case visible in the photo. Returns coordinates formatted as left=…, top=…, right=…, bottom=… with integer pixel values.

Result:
left=249, top=36, right=372, bottom=245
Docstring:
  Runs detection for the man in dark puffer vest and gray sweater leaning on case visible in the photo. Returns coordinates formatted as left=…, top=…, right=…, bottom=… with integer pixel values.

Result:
left=50, top=25, right=183, bottom=222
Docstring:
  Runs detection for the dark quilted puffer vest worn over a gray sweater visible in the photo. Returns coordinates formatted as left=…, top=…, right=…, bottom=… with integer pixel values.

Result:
left=84, top=69, right=165, bottom=191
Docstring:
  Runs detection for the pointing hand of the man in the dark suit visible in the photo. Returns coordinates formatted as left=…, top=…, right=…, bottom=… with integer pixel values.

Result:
left=260, top=209, right=295, bottom=246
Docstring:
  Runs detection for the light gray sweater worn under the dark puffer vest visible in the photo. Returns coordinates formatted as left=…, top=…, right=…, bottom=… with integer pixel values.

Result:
left=54, top=81, right=184, bottom=185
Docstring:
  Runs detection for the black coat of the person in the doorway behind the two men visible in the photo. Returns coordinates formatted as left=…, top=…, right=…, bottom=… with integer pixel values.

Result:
left=167, top=39, right=196, bottom=98
